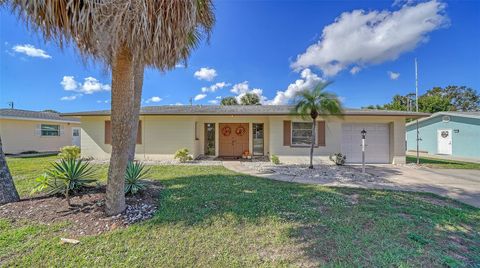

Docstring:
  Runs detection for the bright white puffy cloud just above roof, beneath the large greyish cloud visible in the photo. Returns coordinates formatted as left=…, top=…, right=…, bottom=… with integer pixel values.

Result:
left=268, top=68, right=324, bottom=105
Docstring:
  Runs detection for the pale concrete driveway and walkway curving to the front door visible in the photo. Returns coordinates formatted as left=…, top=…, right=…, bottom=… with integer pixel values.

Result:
left=223, top=161, right=480, bottom=208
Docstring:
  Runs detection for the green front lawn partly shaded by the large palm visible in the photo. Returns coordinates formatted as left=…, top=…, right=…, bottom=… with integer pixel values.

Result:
left=0, top=158, right=480, bottom=267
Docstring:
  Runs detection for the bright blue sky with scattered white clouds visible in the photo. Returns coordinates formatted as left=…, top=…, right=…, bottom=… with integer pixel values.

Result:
left=0, top=0, right=480, bottom=112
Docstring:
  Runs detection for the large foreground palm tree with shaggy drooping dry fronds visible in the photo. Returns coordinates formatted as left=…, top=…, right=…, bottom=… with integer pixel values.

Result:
left=6, top=0, right=215, bottom=215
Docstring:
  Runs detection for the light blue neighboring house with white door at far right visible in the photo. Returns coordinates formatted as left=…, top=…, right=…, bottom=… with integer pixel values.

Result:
left=406, top=112, right=480, bottom=159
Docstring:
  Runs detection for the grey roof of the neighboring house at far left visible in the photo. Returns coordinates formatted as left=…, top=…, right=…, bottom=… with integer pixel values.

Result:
left=0, top=109, right=80, bottom=123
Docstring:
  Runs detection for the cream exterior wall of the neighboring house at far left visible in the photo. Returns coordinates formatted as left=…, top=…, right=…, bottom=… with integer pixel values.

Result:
left=0, top=118, right=80, bottom=154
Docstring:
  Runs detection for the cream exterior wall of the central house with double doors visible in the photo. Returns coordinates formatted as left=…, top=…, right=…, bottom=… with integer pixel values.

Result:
left=81, top=113, right=405, bottom=164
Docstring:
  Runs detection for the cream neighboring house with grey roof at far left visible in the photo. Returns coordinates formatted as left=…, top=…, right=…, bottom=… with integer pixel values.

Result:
left=0, top=109, right=80, bottom=154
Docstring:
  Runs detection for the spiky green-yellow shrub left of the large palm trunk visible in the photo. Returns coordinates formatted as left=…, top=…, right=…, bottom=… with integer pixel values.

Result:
left=32, top=158, right=95, bottom=205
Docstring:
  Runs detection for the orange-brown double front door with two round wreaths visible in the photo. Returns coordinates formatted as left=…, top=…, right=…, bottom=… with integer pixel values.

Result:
left=218, top=123, right=249, bottom=156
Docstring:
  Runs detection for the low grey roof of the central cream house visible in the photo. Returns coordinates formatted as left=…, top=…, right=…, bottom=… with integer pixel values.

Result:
left=63, top=105, right=429, bottom=118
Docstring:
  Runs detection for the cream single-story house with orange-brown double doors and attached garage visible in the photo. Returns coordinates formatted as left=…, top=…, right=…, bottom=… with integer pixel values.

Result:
left=65, top=105, right=427, bottom=163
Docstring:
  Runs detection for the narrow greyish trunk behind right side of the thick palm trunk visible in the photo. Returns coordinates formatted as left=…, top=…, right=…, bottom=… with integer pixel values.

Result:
left=128, top=61, right=145, bottom=162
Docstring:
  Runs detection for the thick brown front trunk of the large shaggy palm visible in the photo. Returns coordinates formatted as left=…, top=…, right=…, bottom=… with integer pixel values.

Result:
left=105, top=47, right=134, bottom=215
